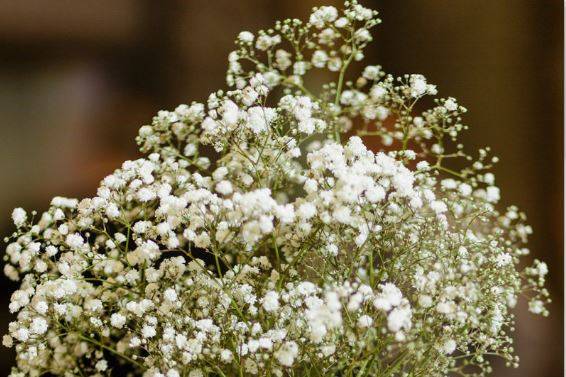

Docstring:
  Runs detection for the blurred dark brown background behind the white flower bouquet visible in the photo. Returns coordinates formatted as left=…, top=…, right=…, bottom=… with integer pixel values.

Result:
left=0, top=0, right=564, bottom=377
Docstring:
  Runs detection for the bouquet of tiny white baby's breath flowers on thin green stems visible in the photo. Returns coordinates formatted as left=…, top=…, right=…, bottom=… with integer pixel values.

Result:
left=3, top=1, right=549, bottom=377
